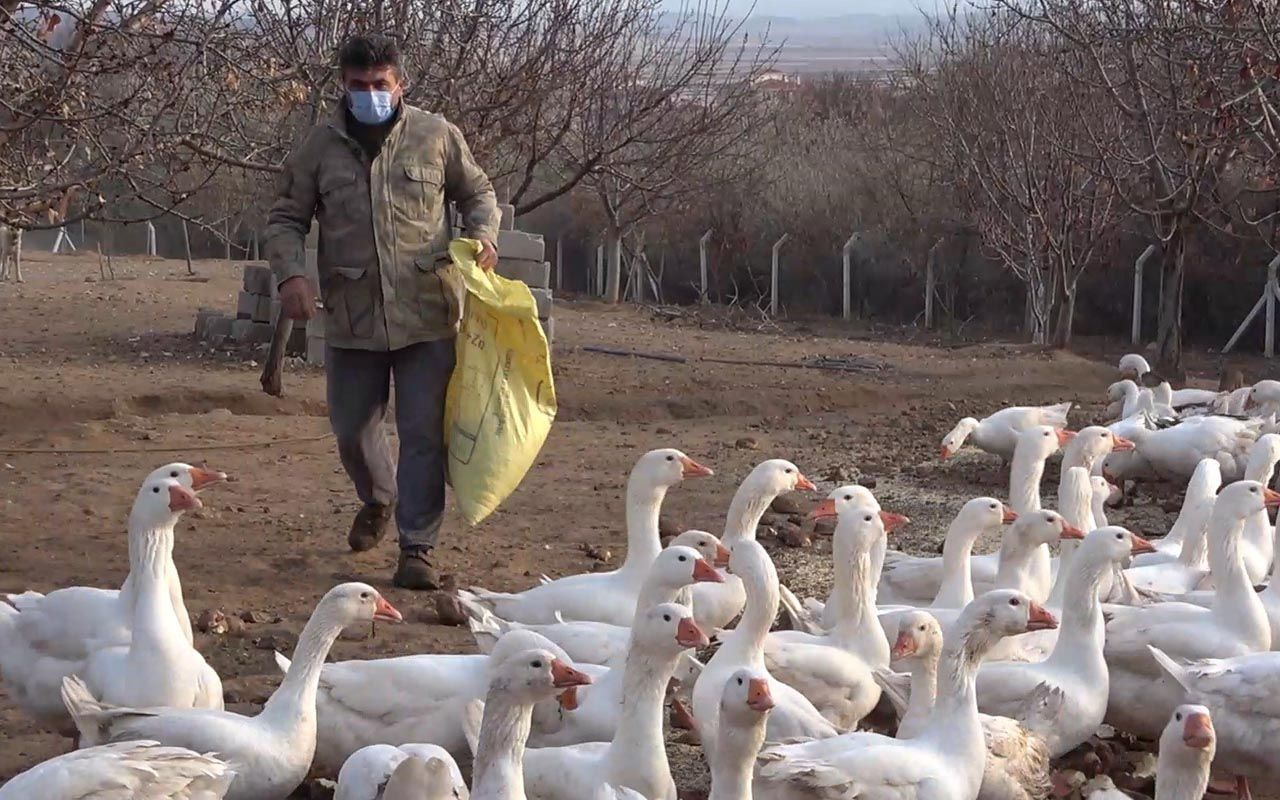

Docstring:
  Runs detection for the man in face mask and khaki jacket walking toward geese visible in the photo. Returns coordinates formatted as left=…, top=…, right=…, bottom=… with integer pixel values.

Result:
left=265, top=36, right=499, bottom=589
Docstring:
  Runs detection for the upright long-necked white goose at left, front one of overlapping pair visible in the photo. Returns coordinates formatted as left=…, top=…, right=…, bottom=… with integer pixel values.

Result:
left=79, top=477, right=223, bottom=709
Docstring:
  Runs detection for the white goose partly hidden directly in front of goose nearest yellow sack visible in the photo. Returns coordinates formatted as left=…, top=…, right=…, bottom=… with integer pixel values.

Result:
left=462, top=531, right=728, bottom=665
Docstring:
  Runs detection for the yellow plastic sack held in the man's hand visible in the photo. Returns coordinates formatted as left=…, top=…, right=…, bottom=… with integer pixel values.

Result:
left=444, top=239, right=556, bottom=525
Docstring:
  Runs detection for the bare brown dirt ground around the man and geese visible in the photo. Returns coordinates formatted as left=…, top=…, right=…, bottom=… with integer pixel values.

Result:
left=0, top=253, right=1269, bottom=788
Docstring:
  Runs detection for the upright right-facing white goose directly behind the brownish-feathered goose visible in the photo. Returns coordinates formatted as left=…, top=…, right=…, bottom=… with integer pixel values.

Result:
left=978, top=527, right=1149, bottom=758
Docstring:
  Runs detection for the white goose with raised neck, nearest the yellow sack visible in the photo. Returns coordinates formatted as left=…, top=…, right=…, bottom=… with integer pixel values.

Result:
left=458, top=449, right=713, bottom=625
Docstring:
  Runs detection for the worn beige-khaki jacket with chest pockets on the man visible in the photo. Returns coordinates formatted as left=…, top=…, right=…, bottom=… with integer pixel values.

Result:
left=265, top=104, right=499, bottom=351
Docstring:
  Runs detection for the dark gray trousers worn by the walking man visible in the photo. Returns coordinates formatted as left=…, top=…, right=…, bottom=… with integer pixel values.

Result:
left=325, top=339, right=454, bottom=549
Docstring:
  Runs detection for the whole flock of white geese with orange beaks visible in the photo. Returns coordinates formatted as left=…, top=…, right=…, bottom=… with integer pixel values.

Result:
left=0, top=356, right=1280, bottom=800
